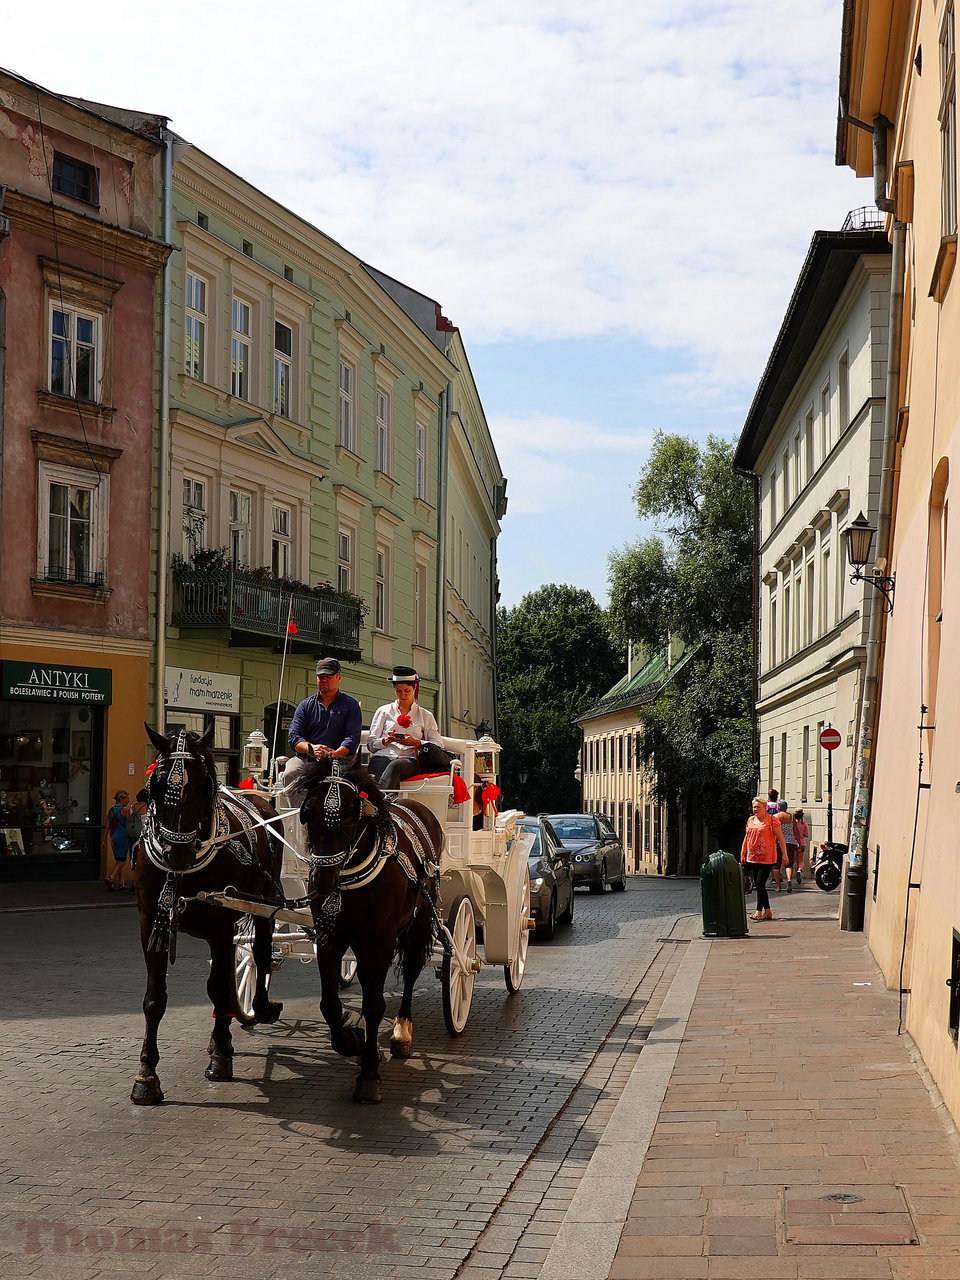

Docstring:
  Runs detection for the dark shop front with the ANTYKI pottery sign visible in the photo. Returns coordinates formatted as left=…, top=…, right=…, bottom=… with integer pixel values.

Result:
left=0, top=662, right=113, bottom=881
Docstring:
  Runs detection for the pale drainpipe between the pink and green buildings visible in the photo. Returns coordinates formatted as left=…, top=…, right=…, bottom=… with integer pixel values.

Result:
left=154, top=129, right=173, bottom=733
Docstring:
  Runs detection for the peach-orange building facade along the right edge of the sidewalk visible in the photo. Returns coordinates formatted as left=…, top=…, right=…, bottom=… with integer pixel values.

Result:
left=837, top=0, right=960, bottom=1120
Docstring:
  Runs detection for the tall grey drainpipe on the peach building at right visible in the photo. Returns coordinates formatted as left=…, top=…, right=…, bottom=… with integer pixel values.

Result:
left=840, top=221, right=906, bottom=932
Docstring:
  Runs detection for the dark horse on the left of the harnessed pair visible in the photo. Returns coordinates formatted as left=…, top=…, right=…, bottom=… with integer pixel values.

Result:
left=131, top=724, right=283, bottom=1106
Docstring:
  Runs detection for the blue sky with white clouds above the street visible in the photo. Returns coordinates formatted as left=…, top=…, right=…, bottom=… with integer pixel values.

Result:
left=0, top=0, right=872, bottom=607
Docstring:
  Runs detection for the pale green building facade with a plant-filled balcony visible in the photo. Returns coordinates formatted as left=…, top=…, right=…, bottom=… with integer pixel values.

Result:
left=160, top=142, right=506, bottom=781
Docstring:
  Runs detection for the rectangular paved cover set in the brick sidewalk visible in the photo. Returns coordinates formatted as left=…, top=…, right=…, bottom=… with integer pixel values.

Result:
left=783, top=1183, right=920, bottom=1245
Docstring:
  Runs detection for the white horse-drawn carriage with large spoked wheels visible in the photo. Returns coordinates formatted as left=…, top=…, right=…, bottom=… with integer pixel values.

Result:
left=215, top=733, right=534, bottom=1036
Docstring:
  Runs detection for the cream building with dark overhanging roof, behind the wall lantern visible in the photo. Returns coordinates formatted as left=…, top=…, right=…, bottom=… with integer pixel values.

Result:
left=735, top=224, right=890, bottom=860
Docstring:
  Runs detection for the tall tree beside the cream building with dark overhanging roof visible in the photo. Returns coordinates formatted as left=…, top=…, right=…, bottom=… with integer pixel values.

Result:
left=609, top=431, right=754, bottom=831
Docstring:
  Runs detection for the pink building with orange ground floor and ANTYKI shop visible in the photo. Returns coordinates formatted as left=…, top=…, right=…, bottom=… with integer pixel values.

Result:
left=0, top=72, right=168, bottom=879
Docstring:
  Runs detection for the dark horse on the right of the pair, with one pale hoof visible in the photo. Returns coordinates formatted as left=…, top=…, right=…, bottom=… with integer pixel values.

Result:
left=294, top=760, right=444, bottom=1102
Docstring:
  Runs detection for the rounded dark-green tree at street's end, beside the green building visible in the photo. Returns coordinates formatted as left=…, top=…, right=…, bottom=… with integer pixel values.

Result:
left=497, top=584, right=623, bottom=813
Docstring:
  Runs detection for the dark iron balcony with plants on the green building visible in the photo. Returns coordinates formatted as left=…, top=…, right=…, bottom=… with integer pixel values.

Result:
left=172, top=566, right=365, bottom=660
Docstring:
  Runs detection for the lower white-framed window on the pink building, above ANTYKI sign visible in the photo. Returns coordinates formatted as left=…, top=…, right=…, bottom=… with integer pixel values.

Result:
left=37, top=462, right=110, bottom=586
